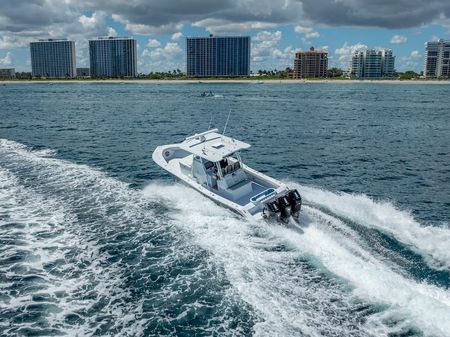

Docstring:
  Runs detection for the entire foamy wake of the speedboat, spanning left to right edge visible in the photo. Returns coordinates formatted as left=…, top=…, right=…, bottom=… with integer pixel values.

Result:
left=0, top=140, right=450, bottom=337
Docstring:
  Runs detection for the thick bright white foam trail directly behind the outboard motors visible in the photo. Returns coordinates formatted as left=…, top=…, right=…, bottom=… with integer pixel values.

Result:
left=286, top=207, right=450, bottom=336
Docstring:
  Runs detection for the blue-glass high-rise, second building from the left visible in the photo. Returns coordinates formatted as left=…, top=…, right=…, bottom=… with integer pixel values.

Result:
left=89, top=37, right=137, bottom=77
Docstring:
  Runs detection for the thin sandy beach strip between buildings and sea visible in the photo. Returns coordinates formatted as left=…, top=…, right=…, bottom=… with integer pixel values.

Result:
left=0, top=79, right=450, bottom=85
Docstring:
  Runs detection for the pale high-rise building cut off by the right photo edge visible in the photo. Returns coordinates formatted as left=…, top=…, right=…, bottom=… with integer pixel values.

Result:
left=423, top=40, right=450, bottom=77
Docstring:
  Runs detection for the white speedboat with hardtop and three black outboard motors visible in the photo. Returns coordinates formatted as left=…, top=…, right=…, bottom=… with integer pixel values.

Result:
left=152, top=129, right=302, bottom=223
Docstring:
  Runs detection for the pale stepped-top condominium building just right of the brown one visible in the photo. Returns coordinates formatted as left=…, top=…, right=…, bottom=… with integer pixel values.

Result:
left=350, top=49, right=395, bottom=78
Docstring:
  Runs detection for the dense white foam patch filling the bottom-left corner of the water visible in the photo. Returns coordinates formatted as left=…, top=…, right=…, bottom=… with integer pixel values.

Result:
left=0, top=170, right=145, bottom=336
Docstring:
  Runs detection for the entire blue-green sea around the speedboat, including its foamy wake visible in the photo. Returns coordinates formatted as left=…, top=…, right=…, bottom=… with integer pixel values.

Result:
left=0, top=83, right=450, bottom=337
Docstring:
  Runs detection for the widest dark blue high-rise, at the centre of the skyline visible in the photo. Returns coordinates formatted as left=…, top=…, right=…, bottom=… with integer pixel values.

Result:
left=186, top=35, right=250, bottom=77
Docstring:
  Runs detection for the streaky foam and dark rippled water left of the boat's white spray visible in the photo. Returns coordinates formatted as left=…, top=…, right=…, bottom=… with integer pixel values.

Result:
left=0, top=140, right=253, bottom=336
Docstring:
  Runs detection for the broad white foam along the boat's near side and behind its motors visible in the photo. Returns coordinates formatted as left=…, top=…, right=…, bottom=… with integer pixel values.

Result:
left=144, top=184, right=450, bottom=336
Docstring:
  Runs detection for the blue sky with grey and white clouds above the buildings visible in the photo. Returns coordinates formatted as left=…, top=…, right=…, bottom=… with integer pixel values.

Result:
left=0, top=0, right=450, bottom=72
